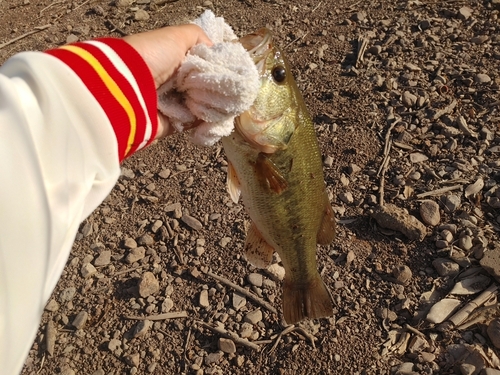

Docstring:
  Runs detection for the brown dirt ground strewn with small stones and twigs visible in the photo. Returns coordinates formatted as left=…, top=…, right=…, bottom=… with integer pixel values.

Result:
left=0, top=0, right=500, bottom=374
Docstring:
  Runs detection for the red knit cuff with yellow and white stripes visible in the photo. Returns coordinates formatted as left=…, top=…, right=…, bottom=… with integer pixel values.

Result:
left=46, top=38, right=158, bottom=162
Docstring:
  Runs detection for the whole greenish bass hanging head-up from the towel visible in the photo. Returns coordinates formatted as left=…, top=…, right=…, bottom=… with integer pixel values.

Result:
left=222, top=28, right=336, bottom=324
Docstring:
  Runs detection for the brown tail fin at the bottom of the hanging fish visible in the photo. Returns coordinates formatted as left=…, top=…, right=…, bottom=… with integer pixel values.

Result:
left=283, top=273, right=333, bottom=324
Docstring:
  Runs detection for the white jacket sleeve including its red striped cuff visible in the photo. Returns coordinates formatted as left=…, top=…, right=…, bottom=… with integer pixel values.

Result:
left=0, top=40, right=156, bottom=375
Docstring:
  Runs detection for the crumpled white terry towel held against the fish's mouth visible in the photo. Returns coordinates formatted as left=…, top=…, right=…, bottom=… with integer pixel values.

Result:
left=158, top=10, right=260, bottom=146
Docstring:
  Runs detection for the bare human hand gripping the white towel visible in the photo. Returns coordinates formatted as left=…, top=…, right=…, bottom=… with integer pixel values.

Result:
left=124, top=25, right=212, bottom=139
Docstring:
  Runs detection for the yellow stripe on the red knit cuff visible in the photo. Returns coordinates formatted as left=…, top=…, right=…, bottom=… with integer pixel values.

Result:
left=59, top=45, right=137, bottom=156
